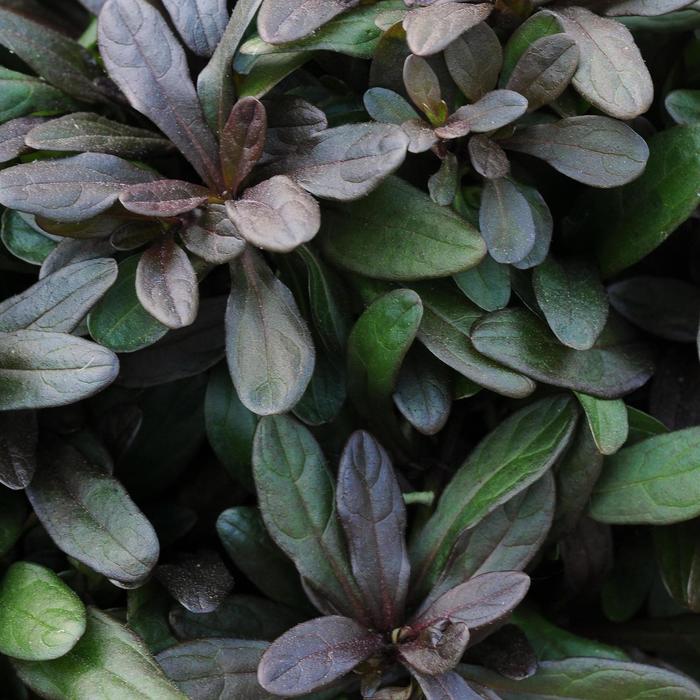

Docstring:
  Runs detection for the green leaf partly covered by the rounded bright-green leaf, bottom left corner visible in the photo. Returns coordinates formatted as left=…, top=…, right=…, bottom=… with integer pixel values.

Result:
left=14, top=608, right=187, bottom=700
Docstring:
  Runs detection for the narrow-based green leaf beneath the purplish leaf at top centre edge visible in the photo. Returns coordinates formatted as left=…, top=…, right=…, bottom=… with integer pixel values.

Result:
left=241, top=0, right=403, bottom=59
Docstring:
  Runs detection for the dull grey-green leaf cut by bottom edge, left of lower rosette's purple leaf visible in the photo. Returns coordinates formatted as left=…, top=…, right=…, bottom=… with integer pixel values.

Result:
left=157, top=639, right=274, bottom=700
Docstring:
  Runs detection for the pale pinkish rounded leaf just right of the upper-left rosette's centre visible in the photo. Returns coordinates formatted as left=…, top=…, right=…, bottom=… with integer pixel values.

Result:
left=226, top=175, right=321, bottom=253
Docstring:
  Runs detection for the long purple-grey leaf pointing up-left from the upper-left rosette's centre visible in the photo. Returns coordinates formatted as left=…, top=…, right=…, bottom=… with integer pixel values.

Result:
left=98, top=0, right=223, bottom=189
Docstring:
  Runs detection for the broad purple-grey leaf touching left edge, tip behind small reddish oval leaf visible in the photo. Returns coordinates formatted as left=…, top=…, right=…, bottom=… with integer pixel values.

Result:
left=0, top=153, right=156, bottom=222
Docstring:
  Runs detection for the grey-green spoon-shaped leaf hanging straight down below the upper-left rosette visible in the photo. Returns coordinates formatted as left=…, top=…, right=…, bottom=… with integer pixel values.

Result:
left=226, top=248, right=315, bottom=415
